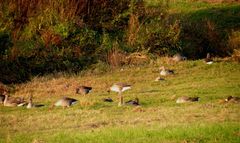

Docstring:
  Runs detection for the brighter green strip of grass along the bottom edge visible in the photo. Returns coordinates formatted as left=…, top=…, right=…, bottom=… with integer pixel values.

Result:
left=4, top=123, right=240, bottom=143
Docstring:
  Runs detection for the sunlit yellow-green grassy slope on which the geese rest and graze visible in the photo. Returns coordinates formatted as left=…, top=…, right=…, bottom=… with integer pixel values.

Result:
left=0, top=58, right=240, bottom=143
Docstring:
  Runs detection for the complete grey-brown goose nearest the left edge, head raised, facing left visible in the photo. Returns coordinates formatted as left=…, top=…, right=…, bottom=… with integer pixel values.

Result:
left=3, top=95, right=26, bottom=107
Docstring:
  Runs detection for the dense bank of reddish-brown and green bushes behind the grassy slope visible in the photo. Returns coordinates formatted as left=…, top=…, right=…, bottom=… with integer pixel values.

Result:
left=0, top=0, right=240, bottom=83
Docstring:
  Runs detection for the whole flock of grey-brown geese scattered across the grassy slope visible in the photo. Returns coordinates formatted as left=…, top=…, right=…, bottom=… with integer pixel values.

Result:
left=0, top=53, right=240, bottom=109
